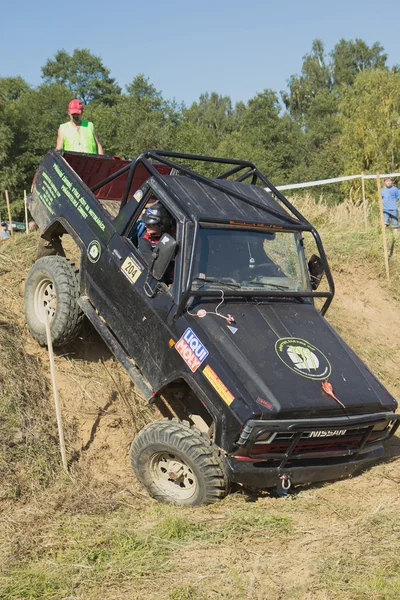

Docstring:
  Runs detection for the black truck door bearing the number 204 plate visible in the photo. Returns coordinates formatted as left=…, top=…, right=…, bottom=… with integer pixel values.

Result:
left=91, top=193, right=179, bottom=388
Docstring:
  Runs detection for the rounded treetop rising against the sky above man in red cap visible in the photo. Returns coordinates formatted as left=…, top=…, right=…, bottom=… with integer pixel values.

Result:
left=42, top=48, right=121, bottom=105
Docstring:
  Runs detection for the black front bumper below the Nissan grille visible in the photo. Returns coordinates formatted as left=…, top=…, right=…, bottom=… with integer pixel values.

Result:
left=226, top=446, right=383, bottom=489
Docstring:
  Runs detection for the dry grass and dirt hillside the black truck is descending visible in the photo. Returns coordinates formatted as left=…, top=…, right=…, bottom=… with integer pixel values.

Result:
left=0, top=200, right=400, bottom=600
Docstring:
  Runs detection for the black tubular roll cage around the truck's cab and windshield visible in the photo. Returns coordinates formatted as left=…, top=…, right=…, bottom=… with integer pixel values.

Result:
left=90, top=149, right=335, bottom=317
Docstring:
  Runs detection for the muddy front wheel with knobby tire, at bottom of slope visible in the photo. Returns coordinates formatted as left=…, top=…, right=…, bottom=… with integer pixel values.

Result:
left=130, top=419, right=229, bottom=506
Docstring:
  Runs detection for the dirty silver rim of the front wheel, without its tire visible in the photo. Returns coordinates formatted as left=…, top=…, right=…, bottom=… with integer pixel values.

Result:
left=150, top=452, right=198, bottom=500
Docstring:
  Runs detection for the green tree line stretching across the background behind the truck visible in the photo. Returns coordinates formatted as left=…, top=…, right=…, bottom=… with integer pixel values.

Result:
left=0, top=39, right=400, bottom=218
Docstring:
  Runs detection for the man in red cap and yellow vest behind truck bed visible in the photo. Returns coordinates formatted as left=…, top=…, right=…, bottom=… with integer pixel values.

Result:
left=56, top=99, right=104, bottom=154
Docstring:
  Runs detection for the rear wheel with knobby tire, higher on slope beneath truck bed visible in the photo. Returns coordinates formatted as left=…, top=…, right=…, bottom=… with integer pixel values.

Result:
left=24, top=256, right=84, bottom=346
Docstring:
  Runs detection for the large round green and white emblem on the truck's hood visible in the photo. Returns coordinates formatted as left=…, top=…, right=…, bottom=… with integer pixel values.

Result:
left=275, top=338, right=332, bottom=379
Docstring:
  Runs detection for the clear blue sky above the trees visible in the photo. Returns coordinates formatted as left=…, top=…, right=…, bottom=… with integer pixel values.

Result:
left=0, top=0, right=400, bottom=104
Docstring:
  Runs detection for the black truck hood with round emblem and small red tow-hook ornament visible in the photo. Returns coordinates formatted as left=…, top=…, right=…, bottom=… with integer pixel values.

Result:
left=190, top=299, right=397, bottom=418
